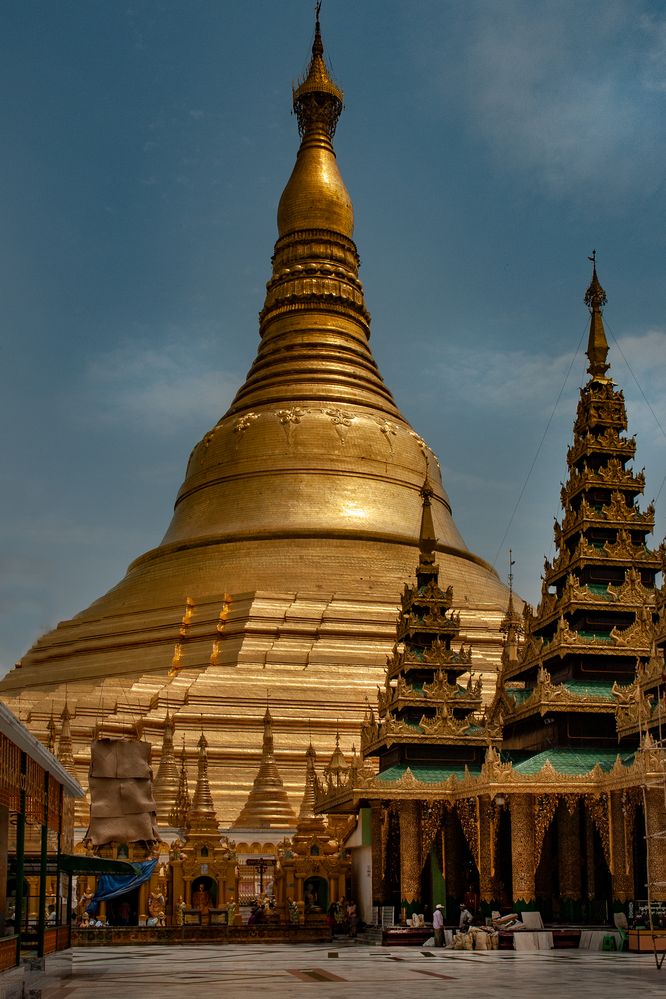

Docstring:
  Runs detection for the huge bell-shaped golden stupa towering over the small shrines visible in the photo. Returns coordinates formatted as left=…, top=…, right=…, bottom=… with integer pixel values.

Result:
left=0, top=13, right=508, bottom=824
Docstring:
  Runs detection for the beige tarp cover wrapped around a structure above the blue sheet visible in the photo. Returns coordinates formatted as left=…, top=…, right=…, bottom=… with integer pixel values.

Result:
left=86, top=739, right=159, bottom=846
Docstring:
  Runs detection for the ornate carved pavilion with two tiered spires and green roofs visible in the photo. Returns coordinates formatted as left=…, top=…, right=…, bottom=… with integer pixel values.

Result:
left=318, top=267, right=666, bottom=921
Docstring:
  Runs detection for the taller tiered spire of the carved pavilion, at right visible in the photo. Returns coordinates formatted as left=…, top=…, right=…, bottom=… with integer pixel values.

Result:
left=502, top=262, right=660, bottom=751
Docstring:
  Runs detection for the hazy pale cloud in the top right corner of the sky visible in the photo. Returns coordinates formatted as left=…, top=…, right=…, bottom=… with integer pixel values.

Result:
left=430, top=0, right=666, bottom=201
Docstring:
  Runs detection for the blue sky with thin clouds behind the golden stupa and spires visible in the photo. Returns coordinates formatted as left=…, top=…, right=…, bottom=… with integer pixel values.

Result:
left=0, top=0, right=666, bottom=667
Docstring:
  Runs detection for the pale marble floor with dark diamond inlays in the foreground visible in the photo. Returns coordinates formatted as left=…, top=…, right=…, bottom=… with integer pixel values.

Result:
left=31, top=943, right=666, bottom=999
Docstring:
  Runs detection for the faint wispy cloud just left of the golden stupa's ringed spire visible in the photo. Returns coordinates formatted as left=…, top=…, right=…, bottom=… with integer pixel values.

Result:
left=83, top=330, right=240, bottom=434
